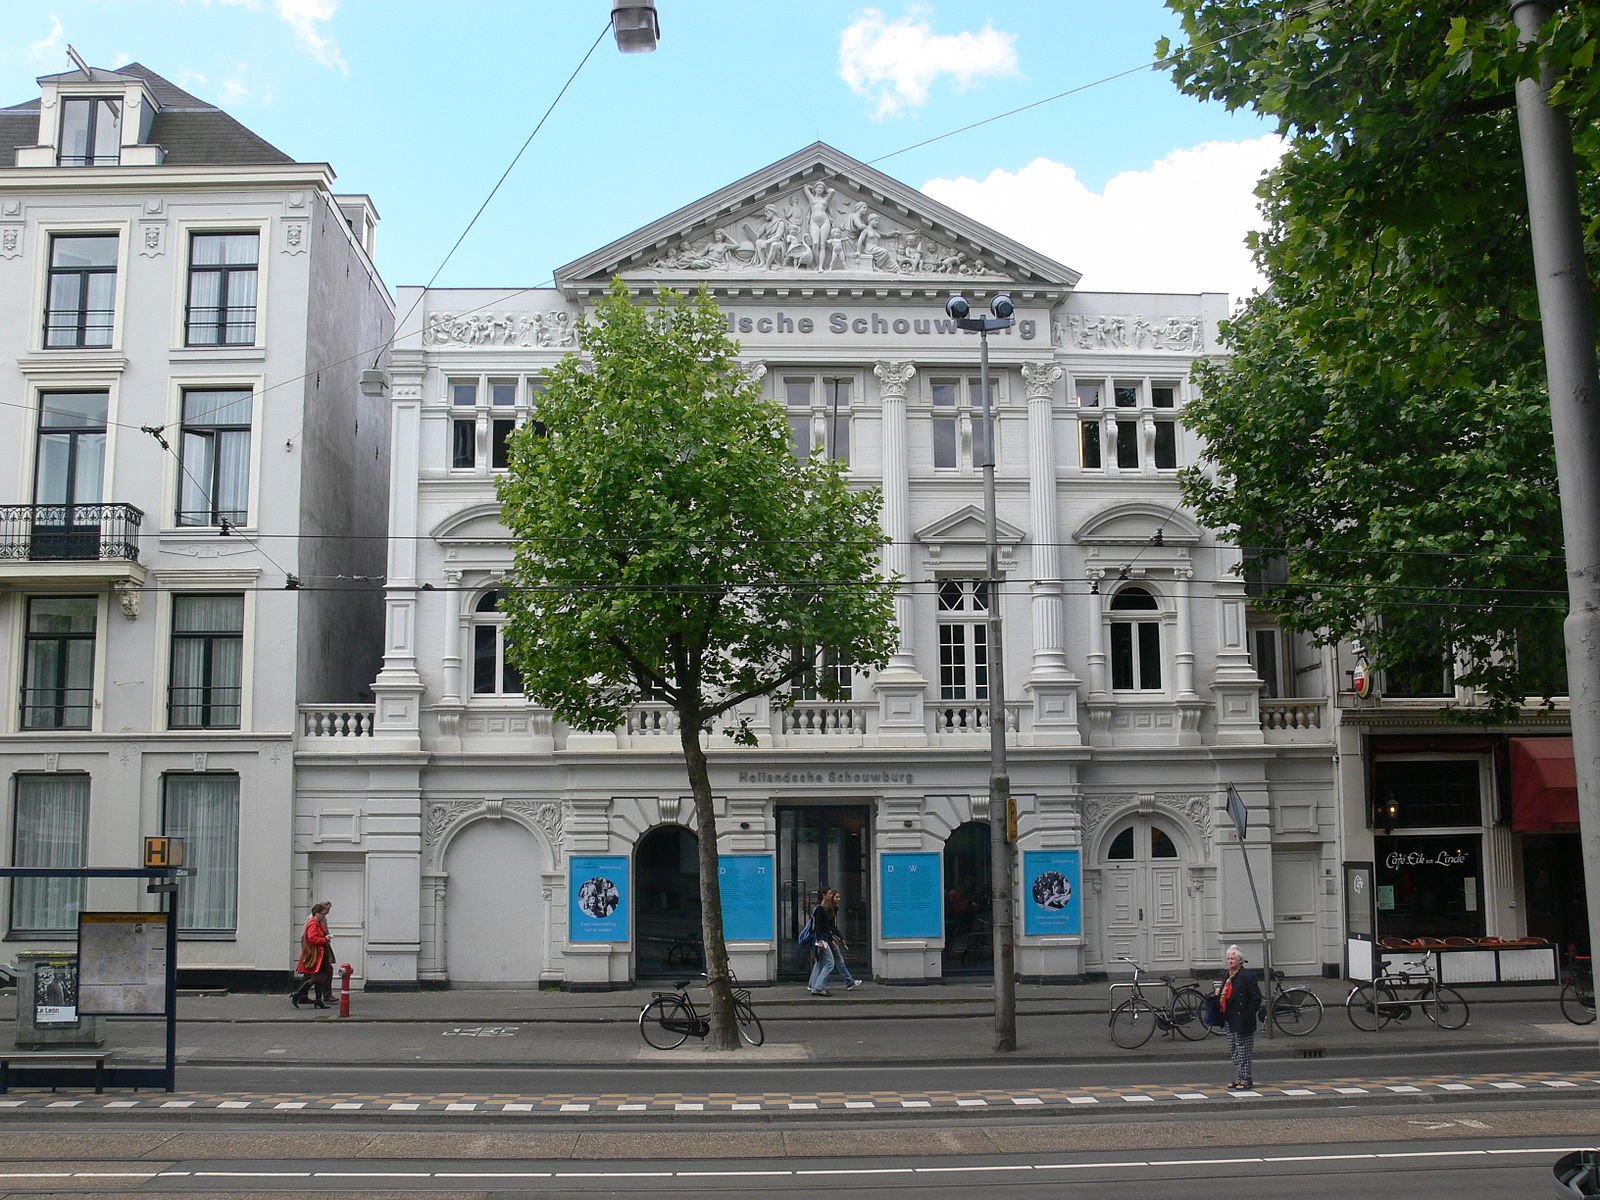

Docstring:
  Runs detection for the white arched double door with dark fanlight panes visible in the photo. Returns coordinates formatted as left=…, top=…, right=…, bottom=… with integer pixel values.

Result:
left=1101, top=816, right=1189, bottom=974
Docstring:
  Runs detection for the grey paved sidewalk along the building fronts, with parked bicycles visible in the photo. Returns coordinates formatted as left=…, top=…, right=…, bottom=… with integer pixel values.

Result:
left=0, top=979, right=1600, bottom=1067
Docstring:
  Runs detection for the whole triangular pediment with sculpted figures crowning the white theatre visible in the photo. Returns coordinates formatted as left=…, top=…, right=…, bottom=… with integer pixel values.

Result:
left=555, top=142, right=1078, bottom=301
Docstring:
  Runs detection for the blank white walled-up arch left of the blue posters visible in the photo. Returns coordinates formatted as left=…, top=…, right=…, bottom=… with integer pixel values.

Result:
left=445, top=821, right=547, bottom=987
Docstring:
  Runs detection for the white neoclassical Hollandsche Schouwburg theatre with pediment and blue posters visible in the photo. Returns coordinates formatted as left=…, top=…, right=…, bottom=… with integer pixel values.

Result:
left=293, top=144, right=1342, bottom=987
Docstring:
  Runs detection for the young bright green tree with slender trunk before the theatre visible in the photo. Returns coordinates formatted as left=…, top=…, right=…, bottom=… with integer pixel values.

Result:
left=499, top=280, right=894, bottom=1050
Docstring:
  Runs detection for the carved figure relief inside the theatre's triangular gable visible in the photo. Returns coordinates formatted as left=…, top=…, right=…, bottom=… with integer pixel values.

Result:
left=645, top=179, right=994, bottom=275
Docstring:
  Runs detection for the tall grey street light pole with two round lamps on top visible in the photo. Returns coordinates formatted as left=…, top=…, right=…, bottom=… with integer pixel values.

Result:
left=944, top=294, right=1016, bottom=1051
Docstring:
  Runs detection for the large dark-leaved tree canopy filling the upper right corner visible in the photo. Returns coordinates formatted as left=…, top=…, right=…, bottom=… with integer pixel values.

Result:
left=1157, top=0, right=1600, bottom=718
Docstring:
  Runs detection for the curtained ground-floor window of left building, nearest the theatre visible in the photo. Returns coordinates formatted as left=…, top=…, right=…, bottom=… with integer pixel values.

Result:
left=162, top=774, right=238, bottom=933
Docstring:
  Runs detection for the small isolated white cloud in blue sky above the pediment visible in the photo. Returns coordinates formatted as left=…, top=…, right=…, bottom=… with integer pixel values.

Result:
left=838, top=5, right=1018, bottom=120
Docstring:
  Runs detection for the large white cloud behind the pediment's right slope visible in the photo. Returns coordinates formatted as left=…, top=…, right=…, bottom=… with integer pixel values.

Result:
left=922, top=134, right=1283, bottom=301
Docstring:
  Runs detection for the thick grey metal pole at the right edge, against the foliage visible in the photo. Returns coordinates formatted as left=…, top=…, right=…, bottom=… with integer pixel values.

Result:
left=1510, top=0, right=1600, bottom=1036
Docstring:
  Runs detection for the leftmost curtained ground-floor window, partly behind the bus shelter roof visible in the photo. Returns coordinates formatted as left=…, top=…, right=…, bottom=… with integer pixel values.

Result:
left=11, top=774, right=90, bottom=936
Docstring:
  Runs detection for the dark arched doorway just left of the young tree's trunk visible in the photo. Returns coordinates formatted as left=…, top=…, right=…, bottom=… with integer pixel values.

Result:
left=634, top=826, right=706, bottom=979
